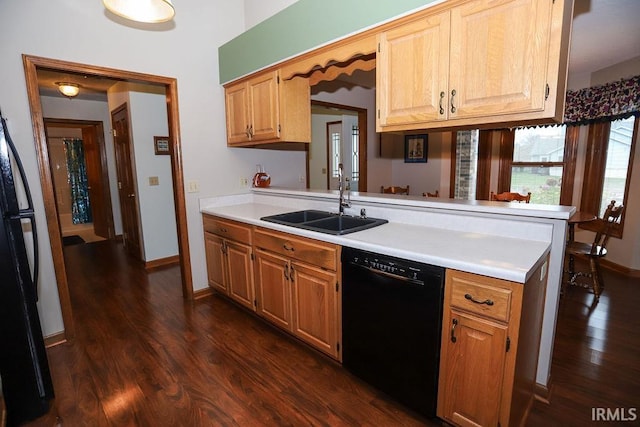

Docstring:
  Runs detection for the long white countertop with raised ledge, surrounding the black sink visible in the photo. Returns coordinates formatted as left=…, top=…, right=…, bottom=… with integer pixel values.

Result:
left=201, top=189, right=572, bottom=283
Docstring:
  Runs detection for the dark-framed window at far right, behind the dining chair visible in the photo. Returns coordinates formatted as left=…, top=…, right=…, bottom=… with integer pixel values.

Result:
left=580, top=116, right=638, bottom=237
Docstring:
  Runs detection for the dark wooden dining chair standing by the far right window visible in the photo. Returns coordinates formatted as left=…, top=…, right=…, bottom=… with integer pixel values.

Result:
left=565, top=200, right=624, bottom=302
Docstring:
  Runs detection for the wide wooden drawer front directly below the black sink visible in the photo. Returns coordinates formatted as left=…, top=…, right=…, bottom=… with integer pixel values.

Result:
left=254, top=228, right=338, bottom=271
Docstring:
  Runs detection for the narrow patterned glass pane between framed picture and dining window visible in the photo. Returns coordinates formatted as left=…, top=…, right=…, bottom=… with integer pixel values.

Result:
left=454, top=129, right=480, bottom=200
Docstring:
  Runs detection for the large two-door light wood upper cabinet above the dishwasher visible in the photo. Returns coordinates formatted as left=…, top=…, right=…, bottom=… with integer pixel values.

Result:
left=376, top=0, right=573, bottom=132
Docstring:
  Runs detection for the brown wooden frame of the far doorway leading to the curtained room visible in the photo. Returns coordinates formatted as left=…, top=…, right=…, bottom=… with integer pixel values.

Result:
left=44, top=117, right=115, bottom=239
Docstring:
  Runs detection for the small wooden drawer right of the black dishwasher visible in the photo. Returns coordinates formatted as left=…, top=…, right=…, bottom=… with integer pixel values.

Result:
left=448, top=271, right=512, bottom=322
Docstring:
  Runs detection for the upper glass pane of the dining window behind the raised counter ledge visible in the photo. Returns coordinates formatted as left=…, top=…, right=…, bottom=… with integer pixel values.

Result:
left=513, top=126, right=566, bottom=162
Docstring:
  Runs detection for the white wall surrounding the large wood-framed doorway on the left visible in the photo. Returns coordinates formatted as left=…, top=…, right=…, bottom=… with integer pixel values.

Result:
left=0, top=0, right=305, bottom=336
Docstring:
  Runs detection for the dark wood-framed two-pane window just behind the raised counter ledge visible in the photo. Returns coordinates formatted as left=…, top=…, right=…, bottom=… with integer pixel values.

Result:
left=498, top=125, right=578, bottom=205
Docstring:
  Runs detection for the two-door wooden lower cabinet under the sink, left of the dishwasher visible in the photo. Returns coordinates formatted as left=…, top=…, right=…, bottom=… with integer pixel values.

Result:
left=255, top=228, right=340, bottom=359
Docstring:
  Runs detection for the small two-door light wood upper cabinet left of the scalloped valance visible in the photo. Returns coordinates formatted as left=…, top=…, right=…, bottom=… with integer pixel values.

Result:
left=225, top=70, right=311, bottom=146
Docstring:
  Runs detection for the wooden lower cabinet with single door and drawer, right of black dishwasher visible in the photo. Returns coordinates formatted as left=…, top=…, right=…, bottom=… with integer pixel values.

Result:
left=438, top=263, right=547, bottom=427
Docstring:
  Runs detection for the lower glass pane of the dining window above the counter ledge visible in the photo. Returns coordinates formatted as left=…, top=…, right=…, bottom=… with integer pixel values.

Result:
left=510, top=166, right=562, bottom=205
